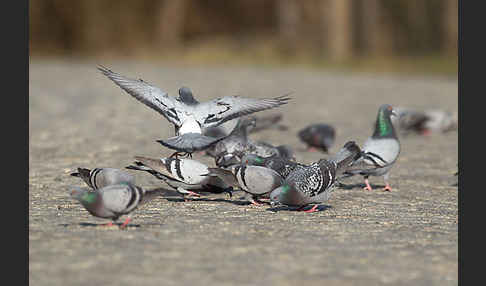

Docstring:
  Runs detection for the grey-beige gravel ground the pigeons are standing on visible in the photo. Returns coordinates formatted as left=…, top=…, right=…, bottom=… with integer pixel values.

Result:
left=29, top=60, right=458, bottom=286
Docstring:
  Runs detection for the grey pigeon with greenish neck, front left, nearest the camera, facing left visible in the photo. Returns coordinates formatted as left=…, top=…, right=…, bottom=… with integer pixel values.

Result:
left=71, top=182, right=151, bottom=228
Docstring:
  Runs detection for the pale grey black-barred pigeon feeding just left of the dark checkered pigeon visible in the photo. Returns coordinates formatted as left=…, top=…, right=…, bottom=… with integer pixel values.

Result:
left=207, top=164, right=284, bottom=205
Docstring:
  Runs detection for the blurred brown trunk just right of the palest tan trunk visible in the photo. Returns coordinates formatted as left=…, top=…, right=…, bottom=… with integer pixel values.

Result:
left=360, top=0, right=392, bottom=56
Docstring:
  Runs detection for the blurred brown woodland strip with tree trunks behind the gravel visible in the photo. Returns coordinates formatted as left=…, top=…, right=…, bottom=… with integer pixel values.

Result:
left=29, top=0, right=458, bottom=75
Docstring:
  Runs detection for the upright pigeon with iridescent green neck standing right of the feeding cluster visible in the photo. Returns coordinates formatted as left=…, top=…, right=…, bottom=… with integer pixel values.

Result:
left=345, top=104, right=400, bottom=191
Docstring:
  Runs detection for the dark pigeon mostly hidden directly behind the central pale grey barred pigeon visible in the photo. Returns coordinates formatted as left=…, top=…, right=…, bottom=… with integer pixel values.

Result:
left=241, top=154, right=306, bottom=179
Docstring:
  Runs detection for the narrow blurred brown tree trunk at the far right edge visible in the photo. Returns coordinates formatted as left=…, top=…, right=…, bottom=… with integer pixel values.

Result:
left=443, top=0, right=459, bottom=54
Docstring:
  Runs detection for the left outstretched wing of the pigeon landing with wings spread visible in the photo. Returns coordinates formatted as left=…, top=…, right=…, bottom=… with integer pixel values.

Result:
left=98, top=66, right=183, bottom=126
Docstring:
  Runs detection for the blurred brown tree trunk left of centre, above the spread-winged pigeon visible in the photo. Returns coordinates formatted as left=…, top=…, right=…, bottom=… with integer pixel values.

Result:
left=155, top=0, right=187, bottom=48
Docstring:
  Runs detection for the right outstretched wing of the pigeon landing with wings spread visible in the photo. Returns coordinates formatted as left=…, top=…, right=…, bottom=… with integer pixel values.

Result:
left=194, top=95, right=290, bottom=128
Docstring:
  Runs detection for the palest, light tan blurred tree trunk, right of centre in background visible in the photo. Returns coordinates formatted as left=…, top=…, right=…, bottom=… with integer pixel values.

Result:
left=323, top=0, right=353, bottom=61
